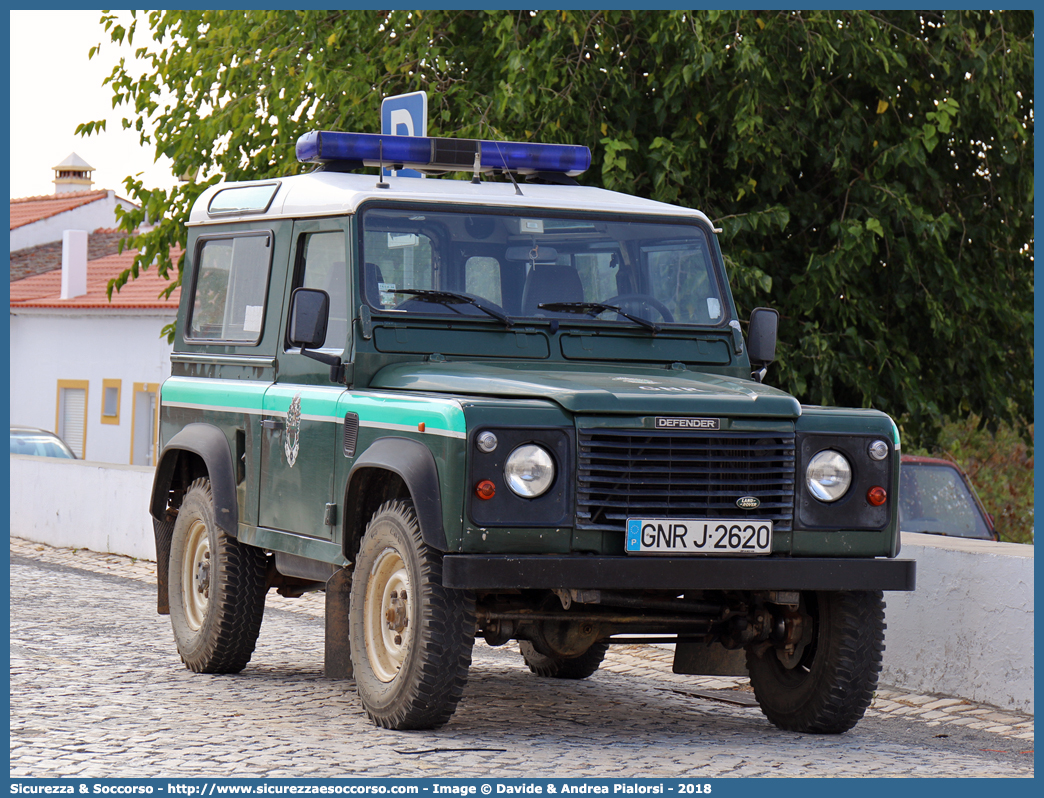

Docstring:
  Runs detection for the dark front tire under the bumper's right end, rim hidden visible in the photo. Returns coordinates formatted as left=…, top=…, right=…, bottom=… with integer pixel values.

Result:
left=746, top=590, right=884, bottom=734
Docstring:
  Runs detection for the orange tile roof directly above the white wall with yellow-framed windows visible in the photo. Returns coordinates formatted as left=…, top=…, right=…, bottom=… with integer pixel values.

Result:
left=10, top=249, right=182, bottom=310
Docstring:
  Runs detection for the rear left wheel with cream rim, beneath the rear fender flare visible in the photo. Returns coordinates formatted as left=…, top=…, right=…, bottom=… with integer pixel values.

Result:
left=167, top=478, right=266, bottom=674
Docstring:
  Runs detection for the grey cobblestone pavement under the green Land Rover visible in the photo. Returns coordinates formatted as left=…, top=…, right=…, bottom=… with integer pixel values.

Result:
left=10, top=538, right=1034, bottom=778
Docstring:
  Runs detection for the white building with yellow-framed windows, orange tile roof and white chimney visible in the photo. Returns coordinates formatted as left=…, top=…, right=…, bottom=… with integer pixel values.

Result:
left=10, top=230, right=180, bottom=465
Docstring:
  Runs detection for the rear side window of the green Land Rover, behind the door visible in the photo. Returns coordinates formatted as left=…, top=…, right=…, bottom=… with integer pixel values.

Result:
left=186, top=233, right=271, bottom=344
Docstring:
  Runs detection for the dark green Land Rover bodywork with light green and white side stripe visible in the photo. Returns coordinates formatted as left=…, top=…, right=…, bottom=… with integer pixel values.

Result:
left=154, top=183, right=899, bottom=566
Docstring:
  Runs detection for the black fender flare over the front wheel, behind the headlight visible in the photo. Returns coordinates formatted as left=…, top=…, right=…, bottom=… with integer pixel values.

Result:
left=346, top=438, right=449, bottom=553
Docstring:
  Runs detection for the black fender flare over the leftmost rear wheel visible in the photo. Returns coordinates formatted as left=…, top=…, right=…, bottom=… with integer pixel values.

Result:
left=149, top=423, right=239, bottom=538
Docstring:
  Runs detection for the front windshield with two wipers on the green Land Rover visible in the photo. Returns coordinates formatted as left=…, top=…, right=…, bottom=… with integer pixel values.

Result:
left=362, top=208, right=728, bottom=329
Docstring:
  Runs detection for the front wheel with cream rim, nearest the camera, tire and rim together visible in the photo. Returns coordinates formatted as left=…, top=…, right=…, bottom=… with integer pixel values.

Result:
left=349, top=499, right=475, bottom=730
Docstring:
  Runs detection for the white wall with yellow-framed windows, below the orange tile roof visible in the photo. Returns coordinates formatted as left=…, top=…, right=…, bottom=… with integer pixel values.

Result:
left=10, top=308, right=174, bottom=464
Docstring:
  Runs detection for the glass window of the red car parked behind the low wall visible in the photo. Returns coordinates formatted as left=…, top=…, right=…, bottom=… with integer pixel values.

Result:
left=899, top=463, right=992, bottom=540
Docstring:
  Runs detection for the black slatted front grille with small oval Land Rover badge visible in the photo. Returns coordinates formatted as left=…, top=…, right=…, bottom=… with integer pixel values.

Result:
left=576, top=428, right=794, bottom=532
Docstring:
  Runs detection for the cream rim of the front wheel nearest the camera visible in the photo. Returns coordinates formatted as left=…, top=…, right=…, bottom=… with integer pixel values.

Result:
left=362, top=548, right=413, bottom=683
